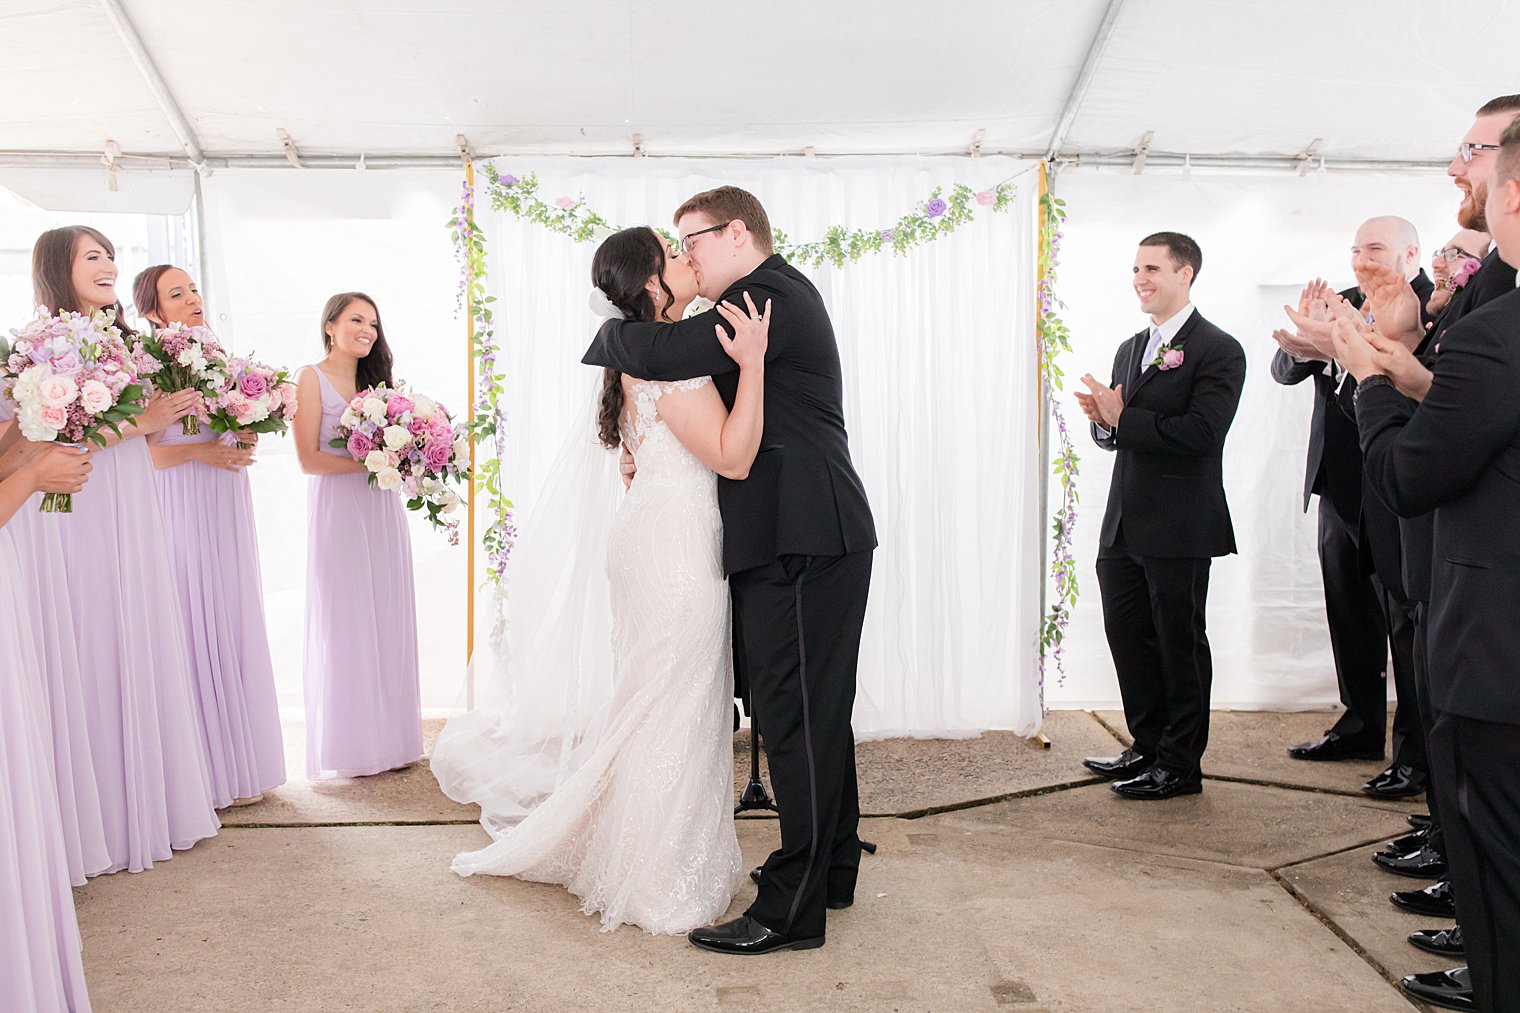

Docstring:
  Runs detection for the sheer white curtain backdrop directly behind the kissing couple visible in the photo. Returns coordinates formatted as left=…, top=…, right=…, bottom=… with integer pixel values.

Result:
left=479, top=158, right=1043, bottom=736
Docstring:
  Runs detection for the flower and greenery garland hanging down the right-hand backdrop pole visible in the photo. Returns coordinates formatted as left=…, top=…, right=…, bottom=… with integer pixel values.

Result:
left=1035, top=193, right=1078, bottom=707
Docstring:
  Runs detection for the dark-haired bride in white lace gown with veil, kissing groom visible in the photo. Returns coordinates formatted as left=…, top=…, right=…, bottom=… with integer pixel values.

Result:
left=432, top=228, right=771, bottom=934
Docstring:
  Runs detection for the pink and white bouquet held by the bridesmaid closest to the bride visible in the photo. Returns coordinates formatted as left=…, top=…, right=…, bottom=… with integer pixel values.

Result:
left=330, top=383, right=470, bottom=545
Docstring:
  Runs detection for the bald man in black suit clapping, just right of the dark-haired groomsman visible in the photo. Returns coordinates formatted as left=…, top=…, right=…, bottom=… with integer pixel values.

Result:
left=1272, top=214, right=1435, bottom=799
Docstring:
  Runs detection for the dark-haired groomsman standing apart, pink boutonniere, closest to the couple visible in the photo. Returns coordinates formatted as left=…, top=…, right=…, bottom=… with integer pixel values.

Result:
left=1076, top=233, right=1245, bottom=799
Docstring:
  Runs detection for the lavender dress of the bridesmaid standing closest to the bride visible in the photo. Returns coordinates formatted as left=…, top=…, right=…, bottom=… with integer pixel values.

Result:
left=306, top=367, right=423, bottom=780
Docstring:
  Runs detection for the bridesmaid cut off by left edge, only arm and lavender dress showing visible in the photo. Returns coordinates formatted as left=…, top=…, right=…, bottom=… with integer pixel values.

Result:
left=0, top=444, right=90, bottom=1011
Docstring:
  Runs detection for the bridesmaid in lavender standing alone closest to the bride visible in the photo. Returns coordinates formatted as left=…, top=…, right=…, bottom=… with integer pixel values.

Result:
left=295, top=292, right=423, bottom=780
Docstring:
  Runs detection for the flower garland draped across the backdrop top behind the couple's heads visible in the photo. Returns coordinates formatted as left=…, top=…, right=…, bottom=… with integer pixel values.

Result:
left=485, top=163, right=1017, bottom=268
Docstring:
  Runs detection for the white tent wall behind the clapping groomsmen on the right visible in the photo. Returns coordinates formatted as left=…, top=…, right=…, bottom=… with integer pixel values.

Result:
left=1046, top=172, right=1458, bottom=710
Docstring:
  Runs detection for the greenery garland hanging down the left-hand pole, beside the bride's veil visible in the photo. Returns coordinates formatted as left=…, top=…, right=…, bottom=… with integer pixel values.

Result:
left=448, top=179, right=517, bottom=586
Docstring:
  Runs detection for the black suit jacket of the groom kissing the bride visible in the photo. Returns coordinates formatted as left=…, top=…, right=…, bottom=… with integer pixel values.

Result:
left=581, top=256, right=876, bottom=573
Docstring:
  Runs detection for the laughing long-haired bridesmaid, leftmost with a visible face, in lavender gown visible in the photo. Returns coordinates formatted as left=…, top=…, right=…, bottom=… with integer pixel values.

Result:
left=32, top=225, right=220, bottom=872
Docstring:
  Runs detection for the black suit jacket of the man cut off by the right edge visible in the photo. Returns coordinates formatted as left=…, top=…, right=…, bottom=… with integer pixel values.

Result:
left=1357, top=289, right=1520, bottom=724
